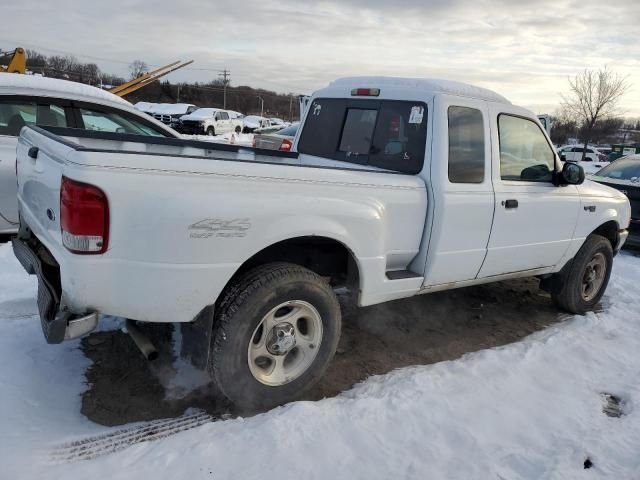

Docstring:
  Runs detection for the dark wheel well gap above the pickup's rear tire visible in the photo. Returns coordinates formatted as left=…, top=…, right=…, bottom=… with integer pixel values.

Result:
left=232, top=236, right=360, bottom=291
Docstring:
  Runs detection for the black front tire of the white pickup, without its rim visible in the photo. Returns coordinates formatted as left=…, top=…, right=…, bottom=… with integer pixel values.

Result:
left=551, top=234, right=613, bottom=315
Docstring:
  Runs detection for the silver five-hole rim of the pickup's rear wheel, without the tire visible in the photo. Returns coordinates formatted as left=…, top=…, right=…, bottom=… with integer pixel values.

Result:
left=247, top=300, right=322, bottom=387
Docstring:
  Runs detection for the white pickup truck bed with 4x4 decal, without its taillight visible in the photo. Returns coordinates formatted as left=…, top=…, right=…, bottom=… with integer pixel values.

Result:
left=18, top=127, right=427, bottom=328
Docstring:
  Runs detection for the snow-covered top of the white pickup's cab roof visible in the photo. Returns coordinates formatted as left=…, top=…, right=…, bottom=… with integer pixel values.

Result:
left=329, top=77, right=511, bottom=104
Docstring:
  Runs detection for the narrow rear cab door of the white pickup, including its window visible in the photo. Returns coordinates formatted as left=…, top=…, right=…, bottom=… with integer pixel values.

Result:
left=424, top=95, right=494, bottom=287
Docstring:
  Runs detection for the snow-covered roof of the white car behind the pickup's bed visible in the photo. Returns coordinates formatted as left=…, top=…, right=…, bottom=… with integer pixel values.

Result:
left=0, top=73, right=131, bottom=107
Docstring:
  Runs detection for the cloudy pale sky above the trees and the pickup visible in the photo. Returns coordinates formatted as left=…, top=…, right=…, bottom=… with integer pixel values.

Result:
left=0, top=0, right=640, bottom=117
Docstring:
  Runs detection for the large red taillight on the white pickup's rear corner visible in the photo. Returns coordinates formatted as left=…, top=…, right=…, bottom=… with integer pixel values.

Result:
left=60, top=177, right=109, bottom=254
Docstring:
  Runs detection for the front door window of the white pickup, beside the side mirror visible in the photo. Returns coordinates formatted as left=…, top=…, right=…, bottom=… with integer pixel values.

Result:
left=498, top=114, right=555, bottom=182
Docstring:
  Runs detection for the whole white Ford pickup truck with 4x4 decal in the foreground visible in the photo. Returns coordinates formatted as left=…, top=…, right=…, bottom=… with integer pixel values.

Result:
left=14, top=77, right=630, bottom=408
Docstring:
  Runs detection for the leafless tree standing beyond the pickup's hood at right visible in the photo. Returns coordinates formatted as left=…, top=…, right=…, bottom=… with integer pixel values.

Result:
left=562, top=67, right=629, bottom=160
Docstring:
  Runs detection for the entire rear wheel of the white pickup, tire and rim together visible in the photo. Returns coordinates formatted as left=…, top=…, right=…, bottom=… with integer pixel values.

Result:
left=209, top=263, right=341, bottom=410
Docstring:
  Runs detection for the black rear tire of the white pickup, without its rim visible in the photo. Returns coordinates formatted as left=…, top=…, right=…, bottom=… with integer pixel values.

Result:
left=208, top=263, right=341, bottom=411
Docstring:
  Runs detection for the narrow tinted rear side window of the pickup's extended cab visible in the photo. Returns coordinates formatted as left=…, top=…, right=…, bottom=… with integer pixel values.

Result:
left=448, top=106, right=485, bottom=183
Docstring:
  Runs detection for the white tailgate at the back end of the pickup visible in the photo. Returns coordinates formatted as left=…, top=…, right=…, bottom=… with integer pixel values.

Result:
left=17, top=127, right=73, bottom=252
